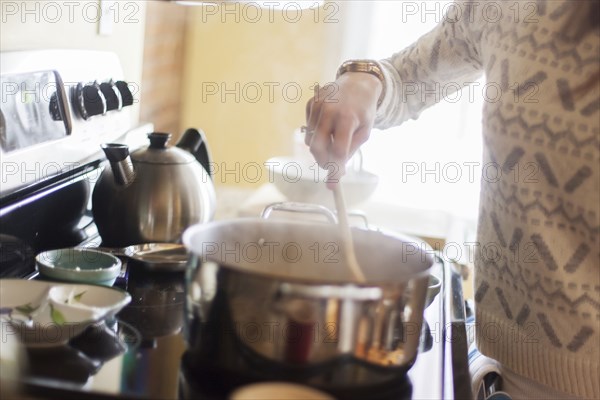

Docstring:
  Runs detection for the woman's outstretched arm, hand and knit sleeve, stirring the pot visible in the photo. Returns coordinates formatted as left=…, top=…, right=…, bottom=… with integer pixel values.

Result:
left=306, top=1, right=483, bottom=181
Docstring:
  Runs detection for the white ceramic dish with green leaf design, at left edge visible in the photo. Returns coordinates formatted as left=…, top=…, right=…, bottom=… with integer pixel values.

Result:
left=0, top=279, right=131, bottom=347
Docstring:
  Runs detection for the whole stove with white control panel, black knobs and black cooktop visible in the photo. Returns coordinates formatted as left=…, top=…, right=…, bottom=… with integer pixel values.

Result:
left=0, top=50, right=470, bottom=399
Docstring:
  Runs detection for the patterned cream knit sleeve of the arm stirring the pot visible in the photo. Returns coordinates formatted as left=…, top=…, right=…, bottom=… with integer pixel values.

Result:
left=375, top=0, right=482, bottom=129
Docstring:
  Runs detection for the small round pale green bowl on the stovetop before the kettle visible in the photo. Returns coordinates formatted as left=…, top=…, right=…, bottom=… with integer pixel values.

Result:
left=35, top=248, right=121, bottom=286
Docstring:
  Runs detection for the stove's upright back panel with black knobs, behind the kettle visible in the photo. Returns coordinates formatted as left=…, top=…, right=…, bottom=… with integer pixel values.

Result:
left=0, top=50, right=152, bottom=272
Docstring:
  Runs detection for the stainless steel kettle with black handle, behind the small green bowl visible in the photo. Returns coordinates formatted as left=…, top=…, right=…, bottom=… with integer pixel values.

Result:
left=92, top=129, right=216, bottom=247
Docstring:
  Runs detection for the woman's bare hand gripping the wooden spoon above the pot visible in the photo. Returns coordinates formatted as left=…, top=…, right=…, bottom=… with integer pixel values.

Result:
left=305, top=72, right=383, bottom=188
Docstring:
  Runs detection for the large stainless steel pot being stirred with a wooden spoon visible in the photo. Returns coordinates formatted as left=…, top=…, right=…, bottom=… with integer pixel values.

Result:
left=183, top=205, right=433, bottom=380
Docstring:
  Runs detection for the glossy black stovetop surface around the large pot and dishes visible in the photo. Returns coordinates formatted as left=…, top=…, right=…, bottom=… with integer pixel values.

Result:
left=14, top=256, right=468, bottom=399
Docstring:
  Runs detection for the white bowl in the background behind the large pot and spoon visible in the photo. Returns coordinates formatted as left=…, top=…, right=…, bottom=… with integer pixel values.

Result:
left=266, top=157, right=379, bottom=208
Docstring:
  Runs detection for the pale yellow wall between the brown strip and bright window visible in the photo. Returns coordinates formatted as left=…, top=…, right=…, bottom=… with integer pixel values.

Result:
left=181, top=5, right=342, bottom=186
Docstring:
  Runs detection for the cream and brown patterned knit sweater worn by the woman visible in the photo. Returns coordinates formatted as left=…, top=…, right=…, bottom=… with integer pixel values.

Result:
left=376, top=0, right=600, bottom=399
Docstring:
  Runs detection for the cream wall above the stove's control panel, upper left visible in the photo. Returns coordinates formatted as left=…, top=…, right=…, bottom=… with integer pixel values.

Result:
left=0, top=0, right=146, bottom=122
